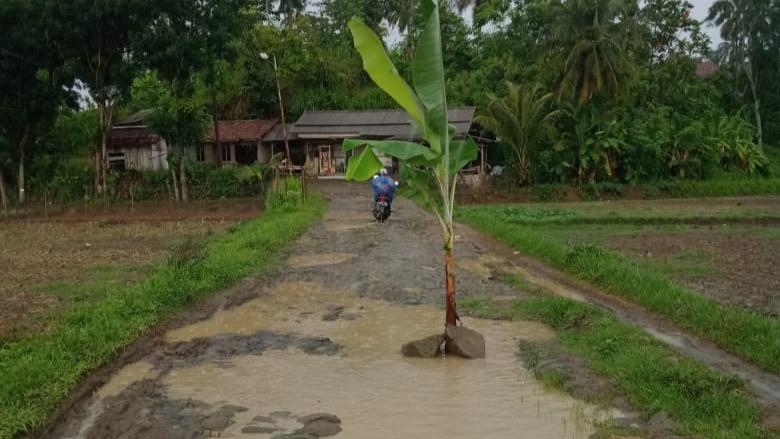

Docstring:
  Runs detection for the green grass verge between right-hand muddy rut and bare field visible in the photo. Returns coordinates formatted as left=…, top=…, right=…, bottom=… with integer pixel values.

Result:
left=458, top=204, right=780, bottom=373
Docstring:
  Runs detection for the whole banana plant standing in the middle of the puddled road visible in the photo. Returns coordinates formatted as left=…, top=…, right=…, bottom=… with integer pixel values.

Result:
left=344, top=0, right=477, bottom=325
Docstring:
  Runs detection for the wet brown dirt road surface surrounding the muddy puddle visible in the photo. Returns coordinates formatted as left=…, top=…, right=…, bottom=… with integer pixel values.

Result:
left=38, top=182, right=772, bottom=439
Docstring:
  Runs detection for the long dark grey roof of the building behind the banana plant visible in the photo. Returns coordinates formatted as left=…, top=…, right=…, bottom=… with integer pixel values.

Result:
left=292, top=107, right=475, bottom=140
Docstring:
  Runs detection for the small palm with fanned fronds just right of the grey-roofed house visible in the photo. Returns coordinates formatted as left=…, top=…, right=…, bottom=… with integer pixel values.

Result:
left=476, top=84, right=558, bottom=184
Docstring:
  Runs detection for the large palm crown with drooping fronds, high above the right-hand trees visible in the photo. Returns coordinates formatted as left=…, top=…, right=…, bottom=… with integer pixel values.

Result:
left=550, top=0, right=638, bottom=103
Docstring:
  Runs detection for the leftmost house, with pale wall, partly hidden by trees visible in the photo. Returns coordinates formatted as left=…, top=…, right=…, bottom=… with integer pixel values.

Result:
left=106, top=110, right=168, bottom=172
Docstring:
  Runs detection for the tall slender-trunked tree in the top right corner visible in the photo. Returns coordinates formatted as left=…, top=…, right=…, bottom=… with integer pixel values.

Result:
left=707, top=0, right=780, bottom=145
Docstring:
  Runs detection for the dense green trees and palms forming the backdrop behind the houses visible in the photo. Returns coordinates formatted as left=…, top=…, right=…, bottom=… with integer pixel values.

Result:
left=0, top=0, right=780, bottom=211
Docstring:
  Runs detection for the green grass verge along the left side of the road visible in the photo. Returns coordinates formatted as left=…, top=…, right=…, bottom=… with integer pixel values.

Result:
left=0, top=195, right=324, bottom=439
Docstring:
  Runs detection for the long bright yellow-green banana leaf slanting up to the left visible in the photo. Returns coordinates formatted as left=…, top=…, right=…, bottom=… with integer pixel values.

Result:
left=348, top=18, right=425, bottom=125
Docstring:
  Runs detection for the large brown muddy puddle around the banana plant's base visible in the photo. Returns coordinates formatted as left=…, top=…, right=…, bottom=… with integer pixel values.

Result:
left=78, top=282, right=616, bottom=439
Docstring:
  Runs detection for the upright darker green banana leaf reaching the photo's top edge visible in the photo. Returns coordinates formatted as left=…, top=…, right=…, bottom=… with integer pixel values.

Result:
left=412, top=0, right=450, bottom=152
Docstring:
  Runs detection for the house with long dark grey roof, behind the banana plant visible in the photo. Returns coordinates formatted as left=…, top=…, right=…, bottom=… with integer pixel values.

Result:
left=291, top=107, right=484, bottom=176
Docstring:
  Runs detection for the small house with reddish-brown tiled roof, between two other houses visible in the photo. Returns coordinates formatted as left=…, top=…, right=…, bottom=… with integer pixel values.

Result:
left=203, top=119, right=276, bottom=165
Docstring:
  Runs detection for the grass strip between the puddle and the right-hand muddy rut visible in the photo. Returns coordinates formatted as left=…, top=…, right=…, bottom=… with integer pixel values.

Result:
left=500, top=297, right=771, bottom=439
